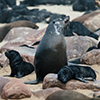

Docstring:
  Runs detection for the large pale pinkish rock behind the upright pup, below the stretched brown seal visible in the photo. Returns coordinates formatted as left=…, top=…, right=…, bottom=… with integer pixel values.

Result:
left=1, top=27, right=45, bottom=51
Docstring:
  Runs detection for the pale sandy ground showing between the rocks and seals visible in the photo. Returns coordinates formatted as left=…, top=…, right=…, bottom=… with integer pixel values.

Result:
left=0, top=0, right=100, bottom=100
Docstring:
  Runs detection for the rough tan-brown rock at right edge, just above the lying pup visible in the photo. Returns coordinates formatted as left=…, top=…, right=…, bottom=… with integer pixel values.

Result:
left=80, top=49, right=100, bottom=65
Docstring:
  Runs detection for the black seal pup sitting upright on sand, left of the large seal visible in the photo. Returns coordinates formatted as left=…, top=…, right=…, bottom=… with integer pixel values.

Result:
left=5, top=50, right=34, bottom=78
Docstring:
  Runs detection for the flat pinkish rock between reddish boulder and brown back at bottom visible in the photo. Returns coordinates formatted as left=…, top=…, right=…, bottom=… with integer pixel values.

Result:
left=32, top=87, right=62, bottom=99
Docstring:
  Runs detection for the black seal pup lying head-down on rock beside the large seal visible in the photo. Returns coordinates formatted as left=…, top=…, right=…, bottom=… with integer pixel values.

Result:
left=58, top=64, right=96, bottom=83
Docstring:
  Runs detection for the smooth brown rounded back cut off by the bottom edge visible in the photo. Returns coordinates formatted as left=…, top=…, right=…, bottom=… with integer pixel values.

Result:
left=46, top=90, right=100, bottom=100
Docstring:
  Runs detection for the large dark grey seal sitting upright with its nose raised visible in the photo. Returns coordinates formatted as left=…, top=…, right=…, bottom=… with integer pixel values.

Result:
left=24, top=16, right=70, bottom=84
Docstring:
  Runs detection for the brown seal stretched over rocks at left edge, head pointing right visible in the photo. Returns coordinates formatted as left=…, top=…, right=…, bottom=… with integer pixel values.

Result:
left=0, top=21, right=39, bottom=42
